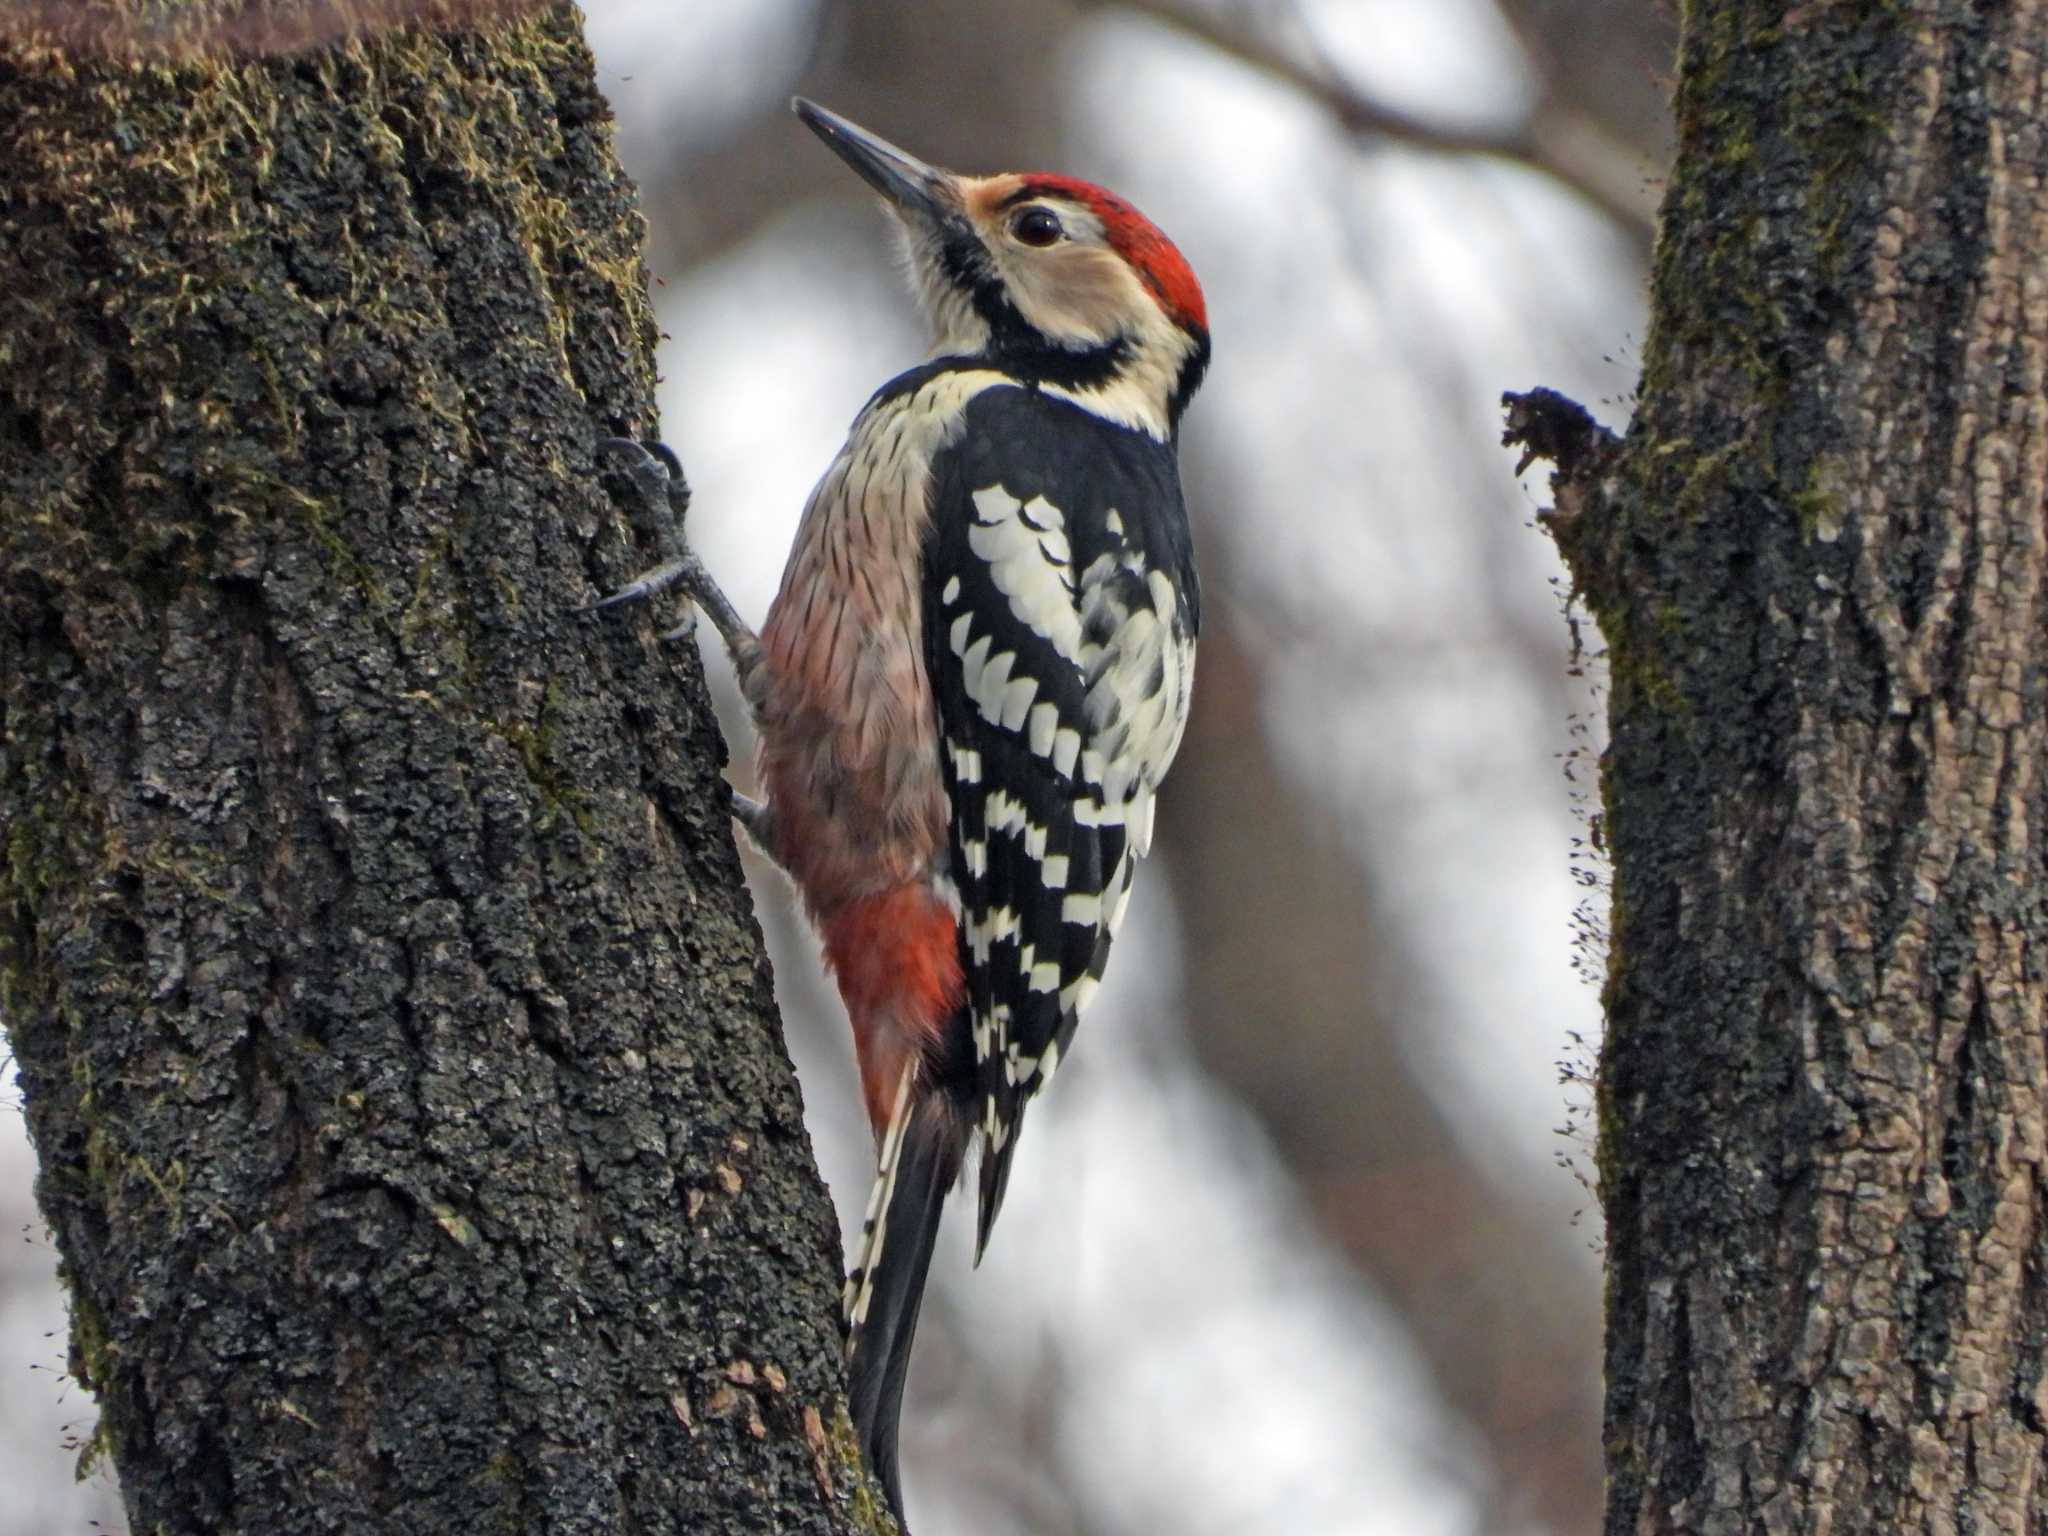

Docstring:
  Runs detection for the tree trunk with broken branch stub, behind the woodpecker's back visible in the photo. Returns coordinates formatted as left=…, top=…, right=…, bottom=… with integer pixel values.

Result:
left=1518, top=0, right=2048, bottom=1536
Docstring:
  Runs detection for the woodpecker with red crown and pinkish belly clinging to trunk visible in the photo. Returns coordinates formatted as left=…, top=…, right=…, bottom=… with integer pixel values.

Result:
left=592, top=98, right=1208, bottom=1522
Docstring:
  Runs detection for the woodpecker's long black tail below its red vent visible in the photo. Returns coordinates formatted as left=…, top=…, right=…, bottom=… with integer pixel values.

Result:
left=848, top=1100, right=965, bottom=1524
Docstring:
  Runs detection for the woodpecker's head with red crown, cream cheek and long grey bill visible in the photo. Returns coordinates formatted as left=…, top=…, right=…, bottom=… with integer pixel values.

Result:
left=795, top=96, right=1208, bottom=438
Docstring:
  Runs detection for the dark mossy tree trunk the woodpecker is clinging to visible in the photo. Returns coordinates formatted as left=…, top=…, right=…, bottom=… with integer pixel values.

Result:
left=0, top=4, right=877, bottom=1536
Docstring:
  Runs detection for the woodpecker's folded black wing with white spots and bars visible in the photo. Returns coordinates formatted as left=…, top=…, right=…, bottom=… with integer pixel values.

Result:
left=924, top=387, right=1200, bottom=1253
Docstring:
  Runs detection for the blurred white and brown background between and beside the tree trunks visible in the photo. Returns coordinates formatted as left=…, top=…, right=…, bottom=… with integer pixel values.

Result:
left=0, top=0, right=1671, bottom=1536
